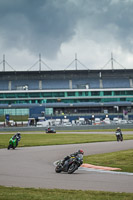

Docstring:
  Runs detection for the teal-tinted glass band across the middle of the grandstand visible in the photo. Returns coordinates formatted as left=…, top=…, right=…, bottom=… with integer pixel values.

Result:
left=0, top=90, right=133, bottom=105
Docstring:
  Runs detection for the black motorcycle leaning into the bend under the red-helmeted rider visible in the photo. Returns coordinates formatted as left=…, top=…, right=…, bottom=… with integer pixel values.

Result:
left=55, top=156, right=83, bottom=174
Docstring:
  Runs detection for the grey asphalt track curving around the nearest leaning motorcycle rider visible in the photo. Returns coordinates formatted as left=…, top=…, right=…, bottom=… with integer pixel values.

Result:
left=0, top=140, right=133, bottom=193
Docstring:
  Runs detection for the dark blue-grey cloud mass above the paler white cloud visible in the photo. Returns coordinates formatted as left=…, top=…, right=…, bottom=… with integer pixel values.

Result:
left=0, top=0, right=133, bottom=58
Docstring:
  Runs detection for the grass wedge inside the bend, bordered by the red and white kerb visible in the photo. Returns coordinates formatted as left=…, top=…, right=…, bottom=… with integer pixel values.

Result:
left=84, top=149, right=133, bottom=173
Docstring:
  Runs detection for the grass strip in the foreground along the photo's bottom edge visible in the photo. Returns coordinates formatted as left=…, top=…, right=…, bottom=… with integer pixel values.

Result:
left=0, top=186, right=133, bottom=200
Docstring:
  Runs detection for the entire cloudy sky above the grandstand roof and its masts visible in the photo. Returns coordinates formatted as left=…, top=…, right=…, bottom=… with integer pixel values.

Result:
left=0, top=0, right=133, bottom=71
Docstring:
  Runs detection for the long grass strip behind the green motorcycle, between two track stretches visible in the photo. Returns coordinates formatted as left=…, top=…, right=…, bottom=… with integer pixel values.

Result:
left=0, top=134, right=133, bottom=148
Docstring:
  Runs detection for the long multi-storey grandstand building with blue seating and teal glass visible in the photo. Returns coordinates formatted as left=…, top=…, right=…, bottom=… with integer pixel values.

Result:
left=0, top=69, right=133, bottom=117
